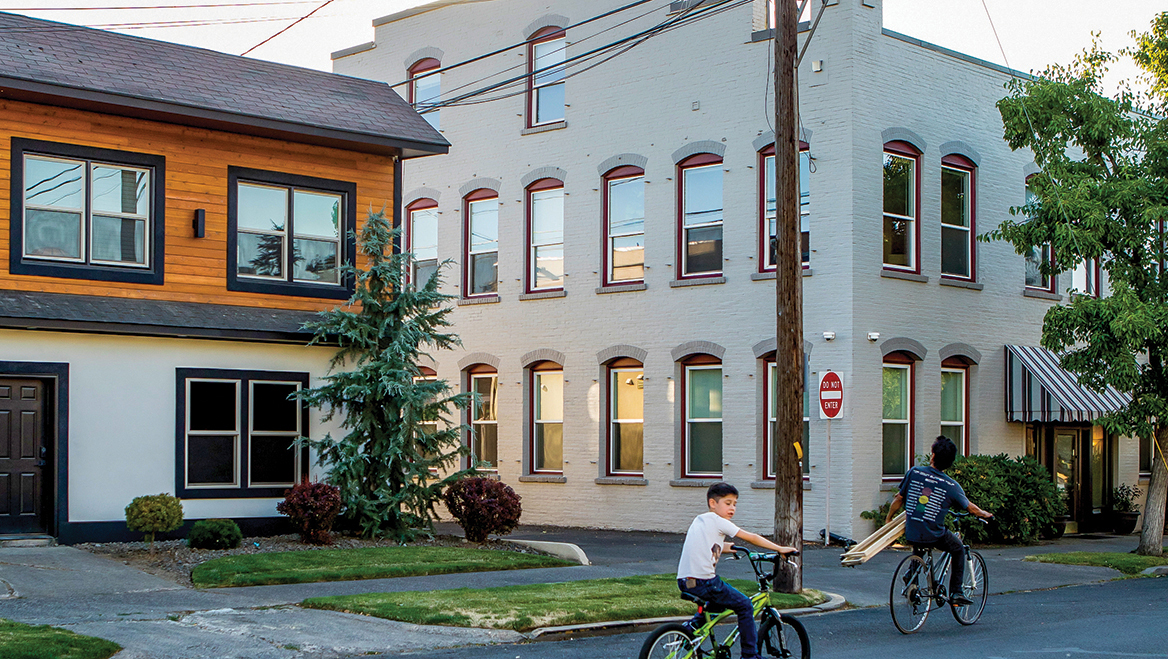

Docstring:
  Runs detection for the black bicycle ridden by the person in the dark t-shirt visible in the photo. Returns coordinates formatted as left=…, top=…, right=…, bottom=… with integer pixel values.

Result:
left=888, top=511, right=989, bottom=633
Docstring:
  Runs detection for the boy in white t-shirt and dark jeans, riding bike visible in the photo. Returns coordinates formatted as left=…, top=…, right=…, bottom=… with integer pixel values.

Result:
left=677, top=483, right=795, bottom=659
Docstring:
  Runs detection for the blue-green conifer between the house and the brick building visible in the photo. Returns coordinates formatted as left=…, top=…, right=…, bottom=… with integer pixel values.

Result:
left=301, top=211, right=473, bottom=541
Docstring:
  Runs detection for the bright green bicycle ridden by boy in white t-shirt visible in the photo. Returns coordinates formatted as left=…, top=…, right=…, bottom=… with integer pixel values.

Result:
left=640, top=544, right=811, bottom=659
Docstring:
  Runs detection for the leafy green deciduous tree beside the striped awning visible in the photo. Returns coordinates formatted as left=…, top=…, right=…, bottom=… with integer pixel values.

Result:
left=983, top=13, right=1168, bottom=555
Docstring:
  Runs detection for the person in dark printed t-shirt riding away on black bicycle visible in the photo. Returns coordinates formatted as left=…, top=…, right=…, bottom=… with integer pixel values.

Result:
left=884, top=435, right=994, bottom=606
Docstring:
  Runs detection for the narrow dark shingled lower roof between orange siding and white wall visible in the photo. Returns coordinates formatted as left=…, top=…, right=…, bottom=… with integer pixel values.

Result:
left=0, top=291, right=327, bottom=344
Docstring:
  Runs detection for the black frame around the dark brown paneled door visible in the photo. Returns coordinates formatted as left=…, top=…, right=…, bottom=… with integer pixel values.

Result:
left=0, top=361, right=69, bottom=537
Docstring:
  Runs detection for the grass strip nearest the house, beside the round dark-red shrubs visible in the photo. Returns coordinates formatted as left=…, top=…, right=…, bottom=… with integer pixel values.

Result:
left=190, top=547, right=576, bottom=587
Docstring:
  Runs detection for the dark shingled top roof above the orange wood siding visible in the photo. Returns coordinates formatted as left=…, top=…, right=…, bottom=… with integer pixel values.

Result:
left=0, top=13, right=450, bottom=158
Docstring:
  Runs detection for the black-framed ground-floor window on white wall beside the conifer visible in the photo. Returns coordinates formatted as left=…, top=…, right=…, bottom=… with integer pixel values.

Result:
left=174, top=368, right=308, bottom=499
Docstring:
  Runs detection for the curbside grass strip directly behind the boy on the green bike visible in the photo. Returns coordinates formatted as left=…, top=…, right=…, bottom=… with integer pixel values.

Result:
left=301, top=575, right=827, bottom=631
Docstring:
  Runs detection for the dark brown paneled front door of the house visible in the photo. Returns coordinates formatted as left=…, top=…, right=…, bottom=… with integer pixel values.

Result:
left=0, top=379, right=48, bottom=533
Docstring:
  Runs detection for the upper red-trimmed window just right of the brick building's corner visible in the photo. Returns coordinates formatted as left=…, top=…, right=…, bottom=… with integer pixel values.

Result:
left=884, top=140, right=920, bottom=272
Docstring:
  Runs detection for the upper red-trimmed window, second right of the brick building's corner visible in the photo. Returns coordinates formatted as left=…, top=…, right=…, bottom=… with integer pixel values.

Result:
left=941, top=155, right=976, bottom=279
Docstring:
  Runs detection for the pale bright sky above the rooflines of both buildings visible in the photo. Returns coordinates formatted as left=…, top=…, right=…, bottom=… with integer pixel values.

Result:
left=0, top=0, right=1168, bottom=94
